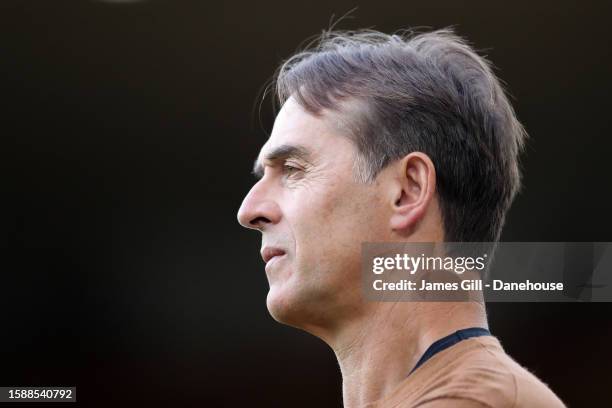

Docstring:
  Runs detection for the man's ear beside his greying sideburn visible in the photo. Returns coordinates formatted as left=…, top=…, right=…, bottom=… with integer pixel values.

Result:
left=390, top=152, right=436, bottom=230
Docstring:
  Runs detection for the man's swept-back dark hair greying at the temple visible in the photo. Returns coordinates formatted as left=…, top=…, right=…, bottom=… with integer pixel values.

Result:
left=275, top=29, right=527, bottom=242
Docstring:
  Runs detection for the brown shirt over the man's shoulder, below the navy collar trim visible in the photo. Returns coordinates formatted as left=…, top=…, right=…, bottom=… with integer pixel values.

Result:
left=385, top=336, right=564, bottom=408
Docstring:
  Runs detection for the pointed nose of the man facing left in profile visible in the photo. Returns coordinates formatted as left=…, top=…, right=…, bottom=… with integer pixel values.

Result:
left=238, top=180, right=281, bottom=231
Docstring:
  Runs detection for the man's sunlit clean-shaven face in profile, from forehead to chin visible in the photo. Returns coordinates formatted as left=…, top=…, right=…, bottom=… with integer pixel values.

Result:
left=238, top=98, right=388, bottom=330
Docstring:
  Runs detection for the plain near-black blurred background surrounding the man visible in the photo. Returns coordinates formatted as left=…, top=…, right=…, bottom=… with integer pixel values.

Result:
left=0, top=0, right=612, bottom=407
